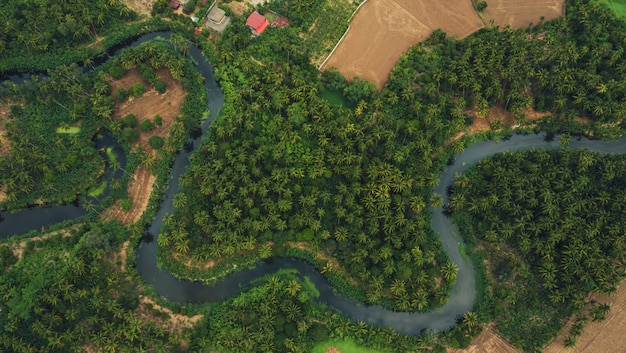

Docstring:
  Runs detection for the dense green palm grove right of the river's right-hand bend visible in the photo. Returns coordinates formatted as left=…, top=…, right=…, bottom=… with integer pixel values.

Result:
left=450, top=150, right=626, bottom=351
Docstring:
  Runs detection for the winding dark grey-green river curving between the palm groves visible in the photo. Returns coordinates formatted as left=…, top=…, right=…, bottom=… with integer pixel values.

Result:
left=0, top=33, right=626, bottom=335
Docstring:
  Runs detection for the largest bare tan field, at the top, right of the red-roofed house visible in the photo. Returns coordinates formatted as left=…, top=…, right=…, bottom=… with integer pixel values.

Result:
left=322, top=0, right=484, bottom=88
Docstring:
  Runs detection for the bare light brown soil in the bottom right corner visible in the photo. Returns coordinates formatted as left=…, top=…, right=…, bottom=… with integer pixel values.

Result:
left=544, top=282, right=626, bottom=353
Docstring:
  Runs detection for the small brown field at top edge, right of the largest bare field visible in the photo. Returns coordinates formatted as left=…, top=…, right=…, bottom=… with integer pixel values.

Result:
left=480, top=0, right=565, bottom=28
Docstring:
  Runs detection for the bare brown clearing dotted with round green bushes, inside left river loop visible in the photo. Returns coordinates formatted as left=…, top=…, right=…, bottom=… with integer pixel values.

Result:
left=111, top=68, right=185, bottom=151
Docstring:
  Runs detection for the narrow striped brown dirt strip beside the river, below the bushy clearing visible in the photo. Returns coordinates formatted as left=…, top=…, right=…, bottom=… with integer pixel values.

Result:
left=102, top=167, right=156, bottom=225
